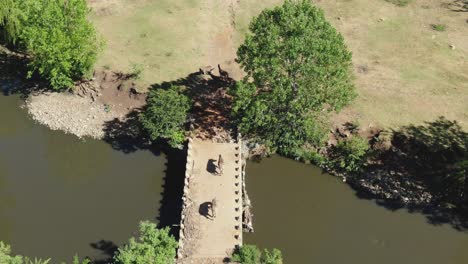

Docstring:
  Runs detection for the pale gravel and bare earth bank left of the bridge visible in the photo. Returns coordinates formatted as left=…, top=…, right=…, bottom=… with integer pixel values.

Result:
left=25, top=71, right=146, bottom=139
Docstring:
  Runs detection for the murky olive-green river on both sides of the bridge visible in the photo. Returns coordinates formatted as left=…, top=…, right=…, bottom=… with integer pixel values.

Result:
left=0, top=92, right=468, bottom=264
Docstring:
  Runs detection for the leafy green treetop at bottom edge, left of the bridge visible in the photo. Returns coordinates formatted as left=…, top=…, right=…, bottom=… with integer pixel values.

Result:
left=114, top=221, right=178, bottom=264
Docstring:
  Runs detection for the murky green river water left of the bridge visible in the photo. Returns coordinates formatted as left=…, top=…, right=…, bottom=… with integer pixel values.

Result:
left=0, top=95, right=166, bottom=263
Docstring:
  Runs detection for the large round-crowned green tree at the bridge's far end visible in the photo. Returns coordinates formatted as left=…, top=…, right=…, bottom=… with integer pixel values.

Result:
left=233, top=0, right=355, bottom=154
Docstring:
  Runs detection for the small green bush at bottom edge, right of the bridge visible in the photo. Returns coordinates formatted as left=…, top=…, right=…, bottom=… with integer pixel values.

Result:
left=232, top=245, right=283, bottom=264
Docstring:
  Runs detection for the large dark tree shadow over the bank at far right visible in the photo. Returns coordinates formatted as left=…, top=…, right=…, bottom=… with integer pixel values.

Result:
left=350, top=117, right=468, bottom=231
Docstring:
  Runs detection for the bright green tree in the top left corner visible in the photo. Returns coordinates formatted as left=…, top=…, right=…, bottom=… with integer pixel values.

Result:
left=0, top=0, right=102, bottom=89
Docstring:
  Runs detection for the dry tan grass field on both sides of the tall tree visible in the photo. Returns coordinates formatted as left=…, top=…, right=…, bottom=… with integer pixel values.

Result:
left=89, top=0, right=468, bottom=128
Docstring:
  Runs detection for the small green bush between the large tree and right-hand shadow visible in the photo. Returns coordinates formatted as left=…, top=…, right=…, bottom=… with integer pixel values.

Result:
left=328, top=136, right=369, bottom=173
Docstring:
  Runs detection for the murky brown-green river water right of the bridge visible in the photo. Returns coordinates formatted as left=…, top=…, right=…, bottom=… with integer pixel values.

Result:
left=244, top=157, right=468, bottom=264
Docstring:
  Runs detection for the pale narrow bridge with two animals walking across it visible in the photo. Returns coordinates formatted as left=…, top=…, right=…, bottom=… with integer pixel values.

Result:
left=177, top=139, right=244, bottom=263
